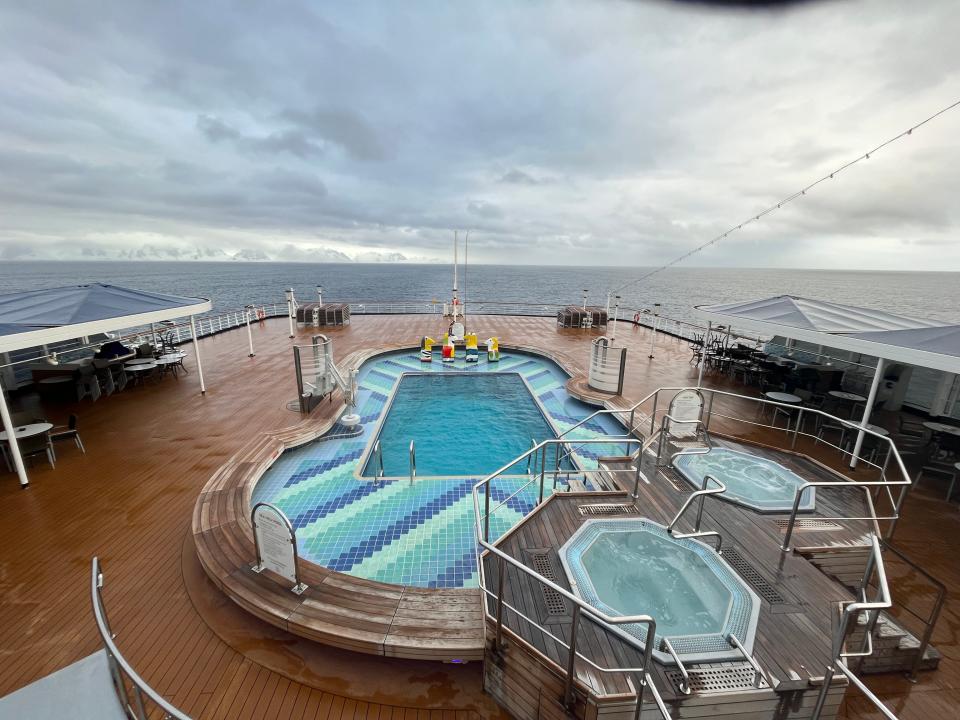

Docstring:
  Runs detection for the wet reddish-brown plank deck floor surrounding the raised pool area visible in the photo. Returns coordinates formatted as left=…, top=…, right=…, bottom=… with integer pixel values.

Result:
left=0, top=315, right=960, bottom=720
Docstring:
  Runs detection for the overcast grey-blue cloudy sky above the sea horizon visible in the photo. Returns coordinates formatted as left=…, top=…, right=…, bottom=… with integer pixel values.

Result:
left=0, top=0, right=960, bottom=270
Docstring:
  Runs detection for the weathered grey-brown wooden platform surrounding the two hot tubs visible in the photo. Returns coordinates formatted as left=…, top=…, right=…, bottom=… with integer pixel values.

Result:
left=483, top=441, right=867, bottom=707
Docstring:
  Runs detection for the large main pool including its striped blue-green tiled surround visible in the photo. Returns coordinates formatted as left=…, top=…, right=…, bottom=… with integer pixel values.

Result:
left=251, top=350, right=625, bottom=587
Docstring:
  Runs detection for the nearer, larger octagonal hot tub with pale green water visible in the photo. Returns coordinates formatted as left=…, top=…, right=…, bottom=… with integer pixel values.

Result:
left=560, top=518, right=760, bottom=662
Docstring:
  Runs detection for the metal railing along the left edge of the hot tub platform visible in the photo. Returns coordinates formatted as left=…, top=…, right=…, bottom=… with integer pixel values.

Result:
left=473, top=439, right=671, bottom=720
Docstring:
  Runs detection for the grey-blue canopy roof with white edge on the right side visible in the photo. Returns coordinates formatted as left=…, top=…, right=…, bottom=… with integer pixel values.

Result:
left=695, top=295, right=960, bottom=373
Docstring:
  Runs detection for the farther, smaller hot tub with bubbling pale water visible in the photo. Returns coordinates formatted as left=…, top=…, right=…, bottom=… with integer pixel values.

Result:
left=674, top=447, right=816, bottom=512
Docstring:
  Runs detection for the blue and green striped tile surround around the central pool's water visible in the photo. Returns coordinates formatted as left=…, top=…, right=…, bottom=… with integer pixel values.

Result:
left=253, top=352, right=624, bottom=587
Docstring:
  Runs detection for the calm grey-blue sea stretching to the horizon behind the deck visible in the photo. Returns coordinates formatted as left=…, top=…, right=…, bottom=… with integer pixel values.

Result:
left=0, top=262, right=960, bottom=322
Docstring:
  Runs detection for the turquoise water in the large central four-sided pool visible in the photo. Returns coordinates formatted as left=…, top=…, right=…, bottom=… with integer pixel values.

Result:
left=363, top=373, right=556, bottom=477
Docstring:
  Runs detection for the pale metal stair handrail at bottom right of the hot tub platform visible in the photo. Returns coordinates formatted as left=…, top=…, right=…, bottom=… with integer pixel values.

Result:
left=810, top=534, right=897, bottom=720
